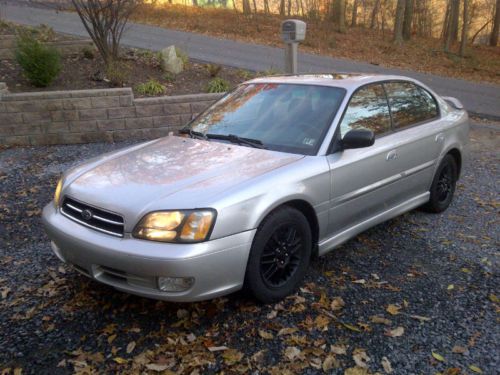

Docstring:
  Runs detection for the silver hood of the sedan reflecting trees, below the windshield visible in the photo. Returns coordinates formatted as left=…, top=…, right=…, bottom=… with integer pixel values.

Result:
left=64, top=136, right=303, bottom=223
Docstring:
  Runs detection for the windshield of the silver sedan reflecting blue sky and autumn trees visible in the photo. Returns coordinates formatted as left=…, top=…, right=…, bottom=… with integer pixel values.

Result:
left=189, top=83, right=345, bottom=155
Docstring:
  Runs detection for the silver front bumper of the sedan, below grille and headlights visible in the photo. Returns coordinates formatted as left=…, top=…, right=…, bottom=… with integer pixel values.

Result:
left=42, top=203, right=255, bottom=302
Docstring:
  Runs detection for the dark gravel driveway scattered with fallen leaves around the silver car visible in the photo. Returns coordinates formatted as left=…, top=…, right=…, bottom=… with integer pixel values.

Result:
left=0, top=124, right=500, bottom=374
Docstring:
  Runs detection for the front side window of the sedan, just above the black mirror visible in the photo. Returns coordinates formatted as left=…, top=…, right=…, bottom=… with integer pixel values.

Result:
left=340, top=84, right=391, bottom=138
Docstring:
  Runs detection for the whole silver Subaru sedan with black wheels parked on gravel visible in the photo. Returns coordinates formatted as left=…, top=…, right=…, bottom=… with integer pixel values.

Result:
left=43, top=74, right=469, bottom=302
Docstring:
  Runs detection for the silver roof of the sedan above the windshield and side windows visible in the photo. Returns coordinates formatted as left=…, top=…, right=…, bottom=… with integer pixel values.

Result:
left=246, top=73, right=416, bottom=89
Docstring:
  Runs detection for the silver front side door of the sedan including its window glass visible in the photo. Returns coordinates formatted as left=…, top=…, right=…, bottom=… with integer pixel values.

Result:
left=327, top=84, right=408, bottom=236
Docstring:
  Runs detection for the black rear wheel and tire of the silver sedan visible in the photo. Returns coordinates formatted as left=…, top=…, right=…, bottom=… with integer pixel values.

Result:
left=422, top=154, right=458, bottom=213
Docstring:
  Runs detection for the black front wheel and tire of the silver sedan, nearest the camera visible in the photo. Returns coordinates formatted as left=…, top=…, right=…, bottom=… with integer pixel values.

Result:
left=245, top=207, right=312, bottom=303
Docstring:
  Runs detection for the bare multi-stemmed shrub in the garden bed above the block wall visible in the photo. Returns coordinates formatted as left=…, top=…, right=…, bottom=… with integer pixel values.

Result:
left=71, top=0, right=144, bottom=64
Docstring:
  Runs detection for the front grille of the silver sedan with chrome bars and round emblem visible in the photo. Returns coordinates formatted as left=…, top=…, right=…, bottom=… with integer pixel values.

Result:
left=61, top=197, right=124, bottom=237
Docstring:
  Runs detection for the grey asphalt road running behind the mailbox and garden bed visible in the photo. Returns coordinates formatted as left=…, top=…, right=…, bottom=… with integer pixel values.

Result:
left=3, top=4, right=500, bottom=119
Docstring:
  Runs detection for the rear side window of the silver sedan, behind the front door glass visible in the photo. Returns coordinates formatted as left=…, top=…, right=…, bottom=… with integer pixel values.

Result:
left=384, top=82, right=439, bottom=129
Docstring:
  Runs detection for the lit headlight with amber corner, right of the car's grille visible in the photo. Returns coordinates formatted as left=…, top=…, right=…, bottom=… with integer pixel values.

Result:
left=133, top=209, right=215, bottom=242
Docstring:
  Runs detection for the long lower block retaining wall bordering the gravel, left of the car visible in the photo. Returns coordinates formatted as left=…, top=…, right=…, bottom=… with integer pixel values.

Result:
left=0, top=83, right=221, bottom=145
